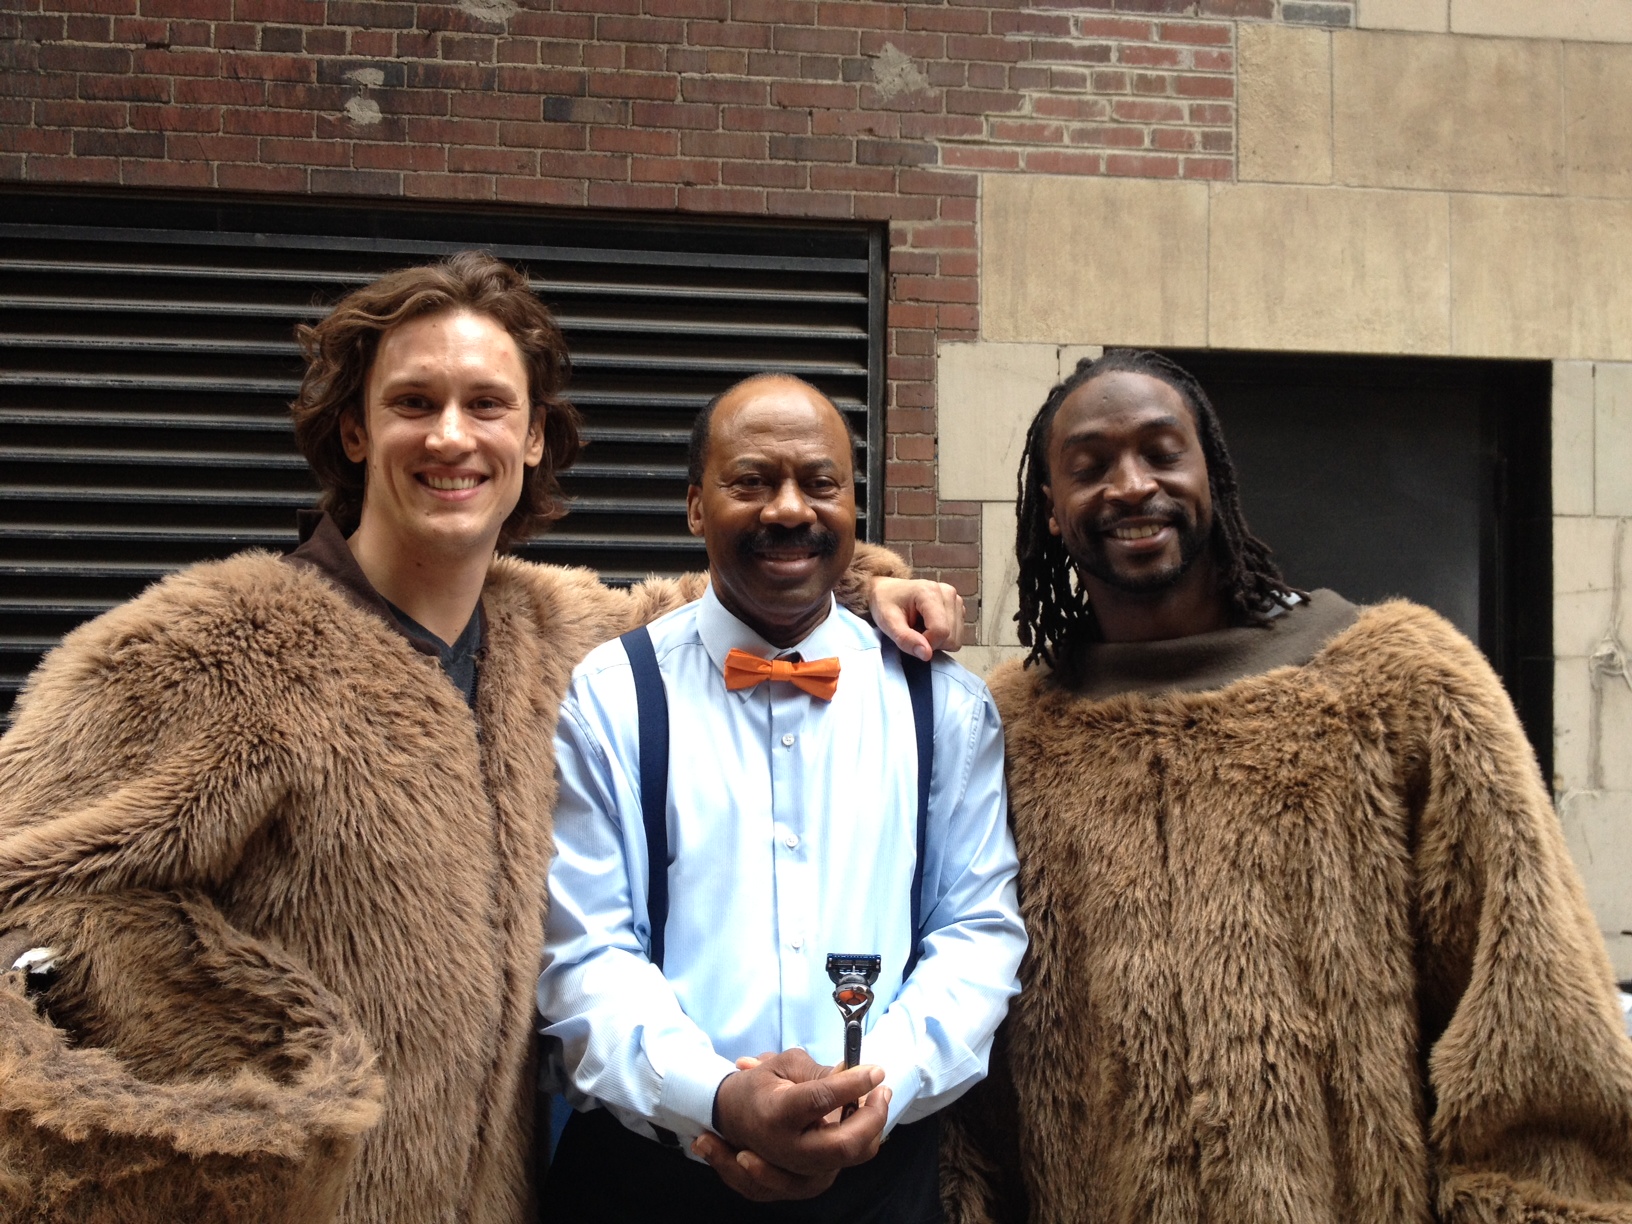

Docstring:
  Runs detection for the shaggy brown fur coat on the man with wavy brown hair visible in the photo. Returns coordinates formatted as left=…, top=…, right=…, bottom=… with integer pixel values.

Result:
left=0, top=548, right=898, bottom=1224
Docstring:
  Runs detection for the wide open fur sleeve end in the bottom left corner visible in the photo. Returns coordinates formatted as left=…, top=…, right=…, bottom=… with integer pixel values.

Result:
left=0, top=893, right=382, bottom=1224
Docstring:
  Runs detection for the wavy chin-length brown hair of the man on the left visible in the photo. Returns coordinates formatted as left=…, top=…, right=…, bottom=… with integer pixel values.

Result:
left=289, top=251, right=583, bottom=548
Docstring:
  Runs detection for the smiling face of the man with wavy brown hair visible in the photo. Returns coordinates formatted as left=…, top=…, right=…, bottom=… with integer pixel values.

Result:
left=341, top=310, right=543, bottom=560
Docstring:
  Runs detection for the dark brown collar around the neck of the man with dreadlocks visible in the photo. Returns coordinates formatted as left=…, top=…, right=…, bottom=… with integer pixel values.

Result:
left=1077, top=589, right=1359, bottom=702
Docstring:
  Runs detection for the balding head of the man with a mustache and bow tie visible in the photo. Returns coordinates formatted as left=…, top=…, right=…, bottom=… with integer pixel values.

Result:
left=685, top=379, right=855, bottom=646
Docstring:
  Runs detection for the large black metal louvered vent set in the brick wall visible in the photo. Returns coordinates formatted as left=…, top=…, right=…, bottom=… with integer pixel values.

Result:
left=0, top=193, right=885, bottom=720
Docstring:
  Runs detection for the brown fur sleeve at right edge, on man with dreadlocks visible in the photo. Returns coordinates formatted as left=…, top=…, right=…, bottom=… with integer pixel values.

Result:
left=1395, top=617, right=1632, bottom=1224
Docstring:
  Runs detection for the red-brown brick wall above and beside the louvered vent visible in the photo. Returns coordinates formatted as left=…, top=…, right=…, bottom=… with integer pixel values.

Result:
left=0, top=0, right=1353, bottom=617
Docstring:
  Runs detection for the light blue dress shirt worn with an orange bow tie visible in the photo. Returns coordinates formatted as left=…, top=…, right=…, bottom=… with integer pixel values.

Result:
left=539, top=589, right=1025, bottom=1141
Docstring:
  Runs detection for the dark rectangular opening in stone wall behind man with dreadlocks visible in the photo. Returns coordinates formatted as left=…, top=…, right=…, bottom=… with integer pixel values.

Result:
left=1172, top=351, right=1552, bottom=777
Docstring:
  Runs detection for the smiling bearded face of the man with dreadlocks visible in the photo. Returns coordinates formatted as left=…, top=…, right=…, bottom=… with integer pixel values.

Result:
left=1044, top=370, right=1213, bottom=601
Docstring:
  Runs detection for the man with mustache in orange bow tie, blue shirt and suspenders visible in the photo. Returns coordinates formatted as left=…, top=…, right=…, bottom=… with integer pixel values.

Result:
left=539, top=377, right=1025, bottom=1224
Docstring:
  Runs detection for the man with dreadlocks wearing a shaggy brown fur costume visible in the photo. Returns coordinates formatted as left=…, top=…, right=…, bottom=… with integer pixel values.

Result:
left=943, top=349, right=1632, bottom=1224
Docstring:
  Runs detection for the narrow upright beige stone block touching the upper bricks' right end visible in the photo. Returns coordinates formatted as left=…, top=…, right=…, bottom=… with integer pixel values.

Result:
left=1235, top=23, right=1332, bottom=183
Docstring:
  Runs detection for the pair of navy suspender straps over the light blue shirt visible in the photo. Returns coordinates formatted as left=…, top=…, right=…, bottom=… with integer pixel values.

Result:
left=620, top=627, right=935, bottom=981
